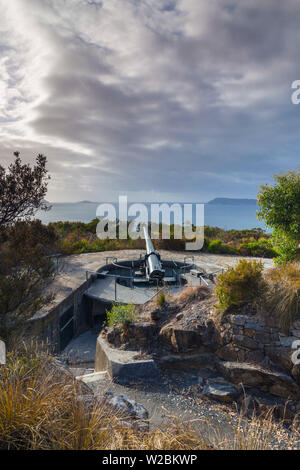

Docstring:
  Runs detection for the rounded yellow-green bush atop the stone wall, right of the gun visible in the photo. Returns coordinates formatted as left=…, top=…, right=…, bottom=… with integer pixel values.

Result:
left=216, top=260, right=266, bottom=310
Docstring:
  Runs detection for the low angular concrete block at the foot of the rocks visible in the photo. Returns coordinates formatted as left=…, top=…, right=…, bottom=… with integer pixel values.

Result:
left=95, top=335, right=159, bottom=378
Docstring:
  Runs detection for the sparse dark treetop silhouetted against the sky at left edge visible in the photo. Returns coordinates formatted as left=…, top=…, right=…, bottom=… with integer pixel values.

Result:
left=0, top=152, right=50, bottom=228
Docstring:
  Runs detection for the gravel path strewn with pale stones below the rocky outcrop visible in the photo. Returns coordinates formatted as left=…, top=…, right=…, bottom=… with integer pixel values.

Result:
left=69, top=368, right=238, bottom=442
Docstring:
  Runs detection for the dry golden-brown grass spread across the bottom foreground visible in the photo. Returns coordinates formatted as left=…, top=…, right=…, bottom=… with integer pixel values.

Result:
left=0, top=349, right=296, bottom=450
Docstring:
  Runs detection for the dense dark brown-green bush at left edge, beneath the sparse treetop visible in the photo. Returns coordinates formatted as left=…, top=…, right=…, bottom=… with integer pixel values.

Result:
left=0, top=220, right=57, bottom=345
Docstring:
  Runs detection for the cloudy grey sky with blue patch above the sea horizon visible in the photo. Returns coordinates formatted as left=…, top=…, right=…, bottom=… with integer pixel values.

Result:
left=0, top=0, right=300, bottom=202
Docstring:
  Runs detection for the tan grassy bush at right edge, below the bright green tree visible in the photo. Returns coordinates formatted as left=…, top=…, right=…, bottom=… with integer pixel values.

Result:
left=266, top=263, right=300, bottom=331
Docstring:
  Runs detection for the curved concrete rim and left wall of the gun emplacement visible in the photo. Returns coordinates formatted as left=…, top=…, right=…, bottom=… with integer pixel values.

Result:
left=30, top=250, right=273, bottom=352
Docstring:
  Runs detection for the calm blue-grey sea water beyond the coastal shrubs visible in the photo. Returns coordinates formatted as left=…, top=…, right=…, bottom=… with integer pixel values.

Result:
left=36, top=202, right=266, bottom=230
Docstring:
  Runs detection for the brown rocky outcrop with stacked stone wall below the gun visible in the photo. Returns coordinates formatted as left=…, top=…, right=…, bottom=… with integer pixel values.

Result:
left=103, top=299, right=300, bottom=400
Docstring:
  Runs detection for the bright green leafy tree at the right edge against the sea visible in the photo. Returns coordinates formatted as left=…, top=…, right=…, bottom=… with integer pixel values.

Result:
left=257, top=170, right=300, bottom=263
